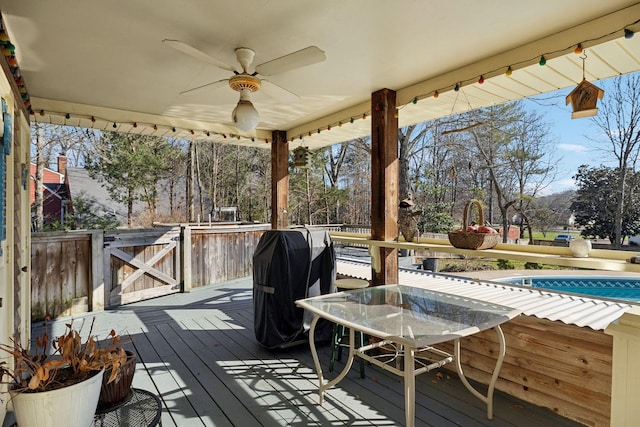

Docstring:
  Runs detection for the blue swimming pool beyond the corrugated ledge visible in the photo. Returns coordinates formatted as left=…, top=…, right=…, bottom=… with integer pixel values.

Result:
left=499, top=276, right=640, bottom=302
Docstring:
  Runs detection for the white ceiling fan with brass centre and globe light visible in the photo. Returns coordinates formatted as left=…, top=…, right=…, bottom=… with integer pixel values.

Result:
left=162, top=39, right=326, bottom=132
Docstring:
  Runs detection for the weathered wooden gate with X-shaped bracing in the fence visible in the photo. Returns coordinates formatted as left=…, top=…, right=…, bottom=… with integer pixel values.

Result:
left=104, top=227, right=182, bottom=305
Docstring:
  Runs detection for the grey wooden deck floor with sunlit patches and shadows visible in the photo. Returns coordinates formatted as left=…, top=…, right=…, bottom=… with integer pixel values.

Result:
left=21, top=278, right=580, bottom=427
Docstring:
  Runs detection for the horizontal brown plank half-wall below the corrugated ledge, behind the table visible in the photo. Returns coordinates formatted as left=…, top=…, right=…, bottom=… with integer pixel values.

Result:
left=437, top=315, right=613, bottom=427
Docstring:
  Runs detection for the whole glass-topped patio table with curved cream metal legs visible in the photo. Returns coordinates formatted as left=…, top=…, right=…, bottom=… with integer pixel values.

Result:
left=296, top=285, right=521, bottom=426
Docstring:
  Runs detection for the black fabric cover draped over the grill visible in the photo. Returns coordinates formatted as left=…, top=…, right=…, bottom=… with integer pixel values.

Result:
left=253, top=229, right=336, bottom=349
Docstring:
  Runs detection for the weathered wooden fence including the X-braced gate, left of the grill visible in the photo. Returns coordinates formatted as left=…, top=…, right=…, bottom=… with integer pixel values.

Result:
left=31, top=224, right=271, bottom=321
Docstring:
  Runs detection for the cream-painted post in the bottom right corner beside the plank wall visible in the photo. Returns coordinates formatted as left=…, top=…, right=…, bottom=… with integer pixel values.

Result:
left=604, top=308, right=640, bottom=427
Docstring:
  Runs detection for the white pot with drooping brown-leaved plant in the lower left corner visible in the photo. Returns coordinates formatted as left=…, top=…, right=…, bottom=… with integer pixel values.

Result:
left=0, top=323, right=126, bottom=427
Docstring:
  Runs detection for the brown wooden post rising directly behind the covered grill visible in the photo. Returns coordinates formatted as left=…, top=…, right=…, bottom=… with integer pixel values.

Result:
left=271, top=130, right=289, bottom=230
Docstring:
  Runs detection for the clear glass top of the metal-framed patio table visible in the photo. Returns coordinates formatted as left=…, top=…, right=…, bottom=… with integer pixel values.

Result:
left=296, top=285, right=520, bottom=348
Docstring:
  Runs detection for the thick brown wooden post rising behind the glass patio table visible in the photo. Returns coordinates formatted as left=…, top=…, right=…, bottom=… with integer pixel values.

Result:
left=371, top=89, right=400, bottom=286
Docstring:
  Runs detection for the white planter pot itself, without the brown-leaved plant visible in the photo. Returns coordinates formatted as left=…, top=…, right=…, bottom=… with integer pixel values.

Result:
left=10, top=370, right=104, bottom=427
